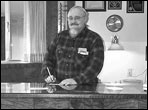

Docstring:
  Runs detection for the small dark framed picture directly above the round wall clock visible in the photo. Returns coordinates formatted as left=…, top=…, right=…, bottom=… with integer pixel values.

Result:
left=108, top=1, right=122, bottom=10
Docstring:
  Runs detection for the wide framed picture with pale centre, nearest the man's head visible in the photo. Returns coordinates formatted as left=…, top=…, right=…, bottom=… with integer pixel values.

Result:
left=83, top=1, right=106, bottom=11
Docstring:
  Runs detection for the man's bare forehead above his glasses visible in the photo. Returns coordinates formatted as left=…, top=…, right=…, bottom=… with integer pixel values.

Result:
left=68, top=8, right=85, bottom=16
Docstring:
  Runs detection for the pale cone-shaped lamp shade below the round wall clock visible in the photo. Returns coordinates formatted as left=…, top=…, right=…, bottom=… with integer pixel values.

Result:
left=108, top=35, right=124, bottom=50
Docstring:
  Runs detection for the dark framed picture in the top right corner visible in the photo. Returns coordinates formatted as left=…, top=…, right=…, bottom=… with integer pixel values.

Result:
left=127, top=1, right=144, bottom=13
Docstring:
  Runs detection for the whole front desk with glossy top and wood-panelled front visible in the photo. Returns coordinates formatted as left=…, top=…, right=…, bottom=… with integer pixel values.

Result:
left=1, top=82, right=147, bottom=109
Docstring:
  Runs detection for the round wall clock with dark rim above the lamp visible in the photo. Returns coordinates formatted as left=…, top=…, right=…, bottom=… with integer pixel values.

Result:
left=106, top=15, right=123, bottom=32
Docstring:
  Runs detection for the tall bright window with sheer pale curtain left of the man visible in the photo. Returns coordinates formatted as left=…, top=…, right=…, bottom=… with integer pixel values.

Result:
left=1, top=1, right=46, bottom=62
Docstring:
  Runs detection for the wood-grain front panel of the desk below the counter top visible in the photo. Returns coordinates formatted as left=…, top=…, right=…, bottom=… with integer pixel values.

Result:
left=1, top=97, right=147, bottom=109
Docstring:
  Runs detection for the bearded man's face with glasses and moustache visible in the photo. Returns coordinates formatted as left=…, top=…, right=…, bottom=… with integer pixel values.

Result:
left=68, top=8, right=86, bottom=34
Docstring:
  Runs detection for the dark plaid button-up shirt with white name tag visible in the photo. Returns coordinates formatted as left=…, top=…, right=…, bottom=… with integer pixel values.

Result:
left=42, top=27, right=104, bottom=84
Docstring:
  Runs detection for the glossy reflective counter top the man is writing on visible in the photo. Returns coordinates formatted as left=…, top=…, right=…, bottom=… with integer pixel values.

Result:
left=1, top=82, right=147, bottom=99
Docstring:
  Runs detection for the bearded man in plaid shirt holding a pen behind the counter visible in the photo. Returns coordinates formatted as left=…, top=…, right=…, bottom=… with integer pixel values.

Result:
left=41, top=6, right=104, bottom=85
